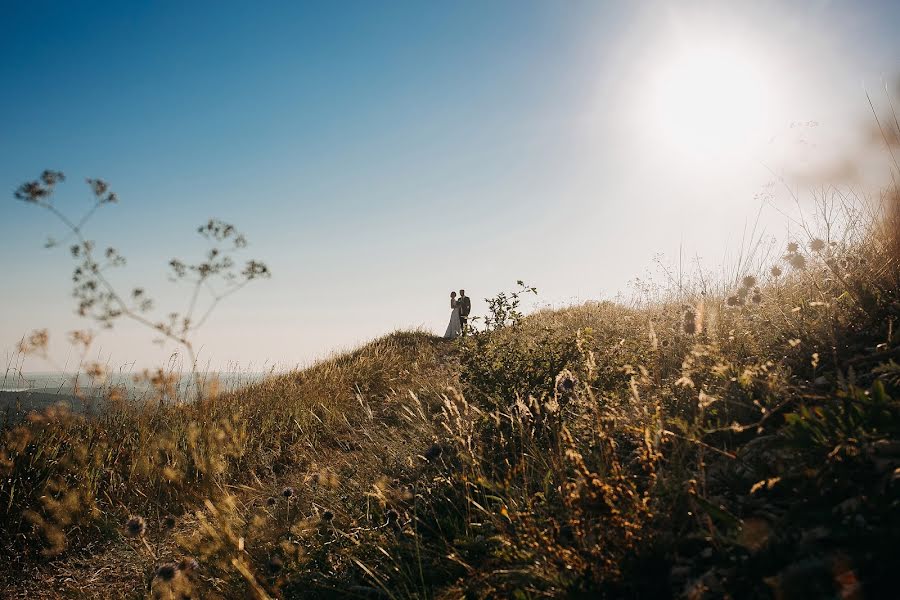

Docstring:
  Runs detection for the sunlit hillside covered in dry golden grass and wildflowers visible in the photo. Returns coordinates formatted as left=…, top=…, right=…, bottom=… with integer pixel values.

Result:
left=0, top=192, right=900, bottom=598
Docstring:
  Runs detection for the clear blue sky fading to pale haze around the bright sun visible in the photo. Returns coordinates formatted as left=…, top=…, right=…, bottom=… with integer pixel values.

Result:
left=0, top=0, right=900, bottom=370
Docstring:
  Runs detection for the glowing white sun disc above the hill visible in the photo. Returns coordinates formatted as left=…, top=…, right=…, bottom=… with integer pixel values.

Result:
left=643, top=41, right=773, bottom=160
